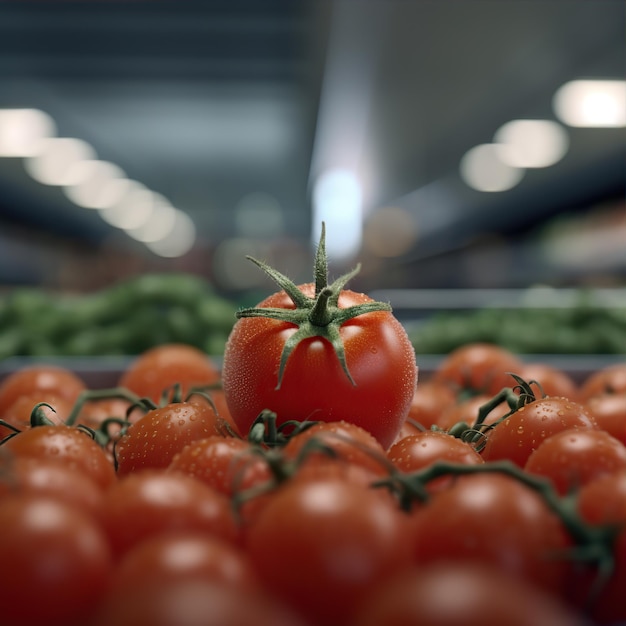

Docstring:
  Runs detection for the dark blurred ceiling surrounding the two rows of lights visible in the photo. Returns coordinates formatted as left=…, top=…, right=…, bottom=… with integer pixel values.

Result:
left=0, top=0, right=626, bottom=286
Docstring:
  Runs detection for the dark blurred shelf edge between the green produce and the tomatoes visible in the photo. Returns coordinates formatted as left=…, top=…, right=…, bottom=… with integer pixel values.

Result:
left=0, top=354, right=626, bottom=389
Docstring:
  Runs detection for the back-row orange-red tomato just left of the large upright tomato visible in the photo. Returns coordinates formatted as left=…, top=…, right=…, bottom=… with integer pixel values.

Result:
left=118, top=343, right=220, bottom=403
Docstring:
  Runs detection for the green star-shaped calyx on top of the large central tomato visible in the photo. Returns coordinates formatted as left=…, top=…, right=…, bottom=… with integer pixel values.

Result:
left=237, top=223, right=391, bottom=389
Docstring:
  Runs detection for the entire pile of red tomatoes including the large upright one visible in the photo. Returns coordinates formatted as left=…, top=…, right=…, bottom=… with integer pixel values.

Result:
left=0, top=233, right=626, bottom=626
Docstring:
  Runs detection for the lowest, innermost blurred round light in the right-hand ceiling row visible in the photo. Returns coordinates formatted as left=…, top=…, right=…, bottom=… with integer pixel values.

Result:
left=460, top=143, right=524, bottom=192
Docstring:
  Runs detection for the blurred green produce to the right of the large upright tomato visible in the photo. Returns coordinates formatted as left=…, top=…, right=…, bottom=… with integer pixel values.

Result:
left=408, top=297, right=626, bottom=354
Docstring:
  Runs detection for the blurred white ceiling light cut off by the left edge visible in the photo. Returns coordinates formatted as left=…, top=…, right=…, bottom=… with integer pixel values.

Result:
left=0, top=109, right=56, bottom=157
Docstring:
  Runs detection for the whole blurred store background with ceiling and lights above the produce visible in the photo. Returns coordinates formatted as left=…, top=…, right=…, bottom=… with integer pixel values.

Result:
left=0, top=0, right=626, bottom=354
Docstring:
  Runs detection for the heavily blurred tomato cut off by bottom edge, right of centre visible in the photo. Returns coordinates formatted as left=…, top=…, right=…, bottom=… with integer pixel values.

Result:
left=350, top=562, right=587, bottom=626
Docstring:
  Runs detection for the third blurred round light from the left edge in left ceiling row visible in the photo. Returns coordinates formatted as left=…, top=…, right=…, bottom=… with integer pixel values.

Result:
left=63, top=159, right=130, bottom=209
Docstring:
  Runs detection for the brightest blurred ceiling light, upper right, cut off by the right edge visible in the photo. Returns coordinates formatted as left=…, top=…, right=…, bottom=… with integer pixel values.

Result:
left=552, top=80, right=626, bottom=128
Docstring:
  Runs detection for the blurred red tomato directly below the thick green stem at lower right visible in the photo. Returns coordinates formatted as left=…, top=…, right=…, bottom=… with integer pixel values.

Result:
left=414, top=472, right=571, bottom=594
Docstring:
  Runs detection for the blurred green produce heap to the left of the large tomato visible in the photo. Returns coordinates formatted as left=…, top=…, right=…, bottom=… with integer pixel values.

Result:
left=0, top=273, right=237, bottom=359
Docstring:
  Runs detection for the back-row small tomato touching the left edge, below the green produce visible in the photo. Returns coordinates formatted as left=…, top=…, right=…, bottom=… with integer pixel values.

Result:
left=0, top=365, right=86, bottom=418
